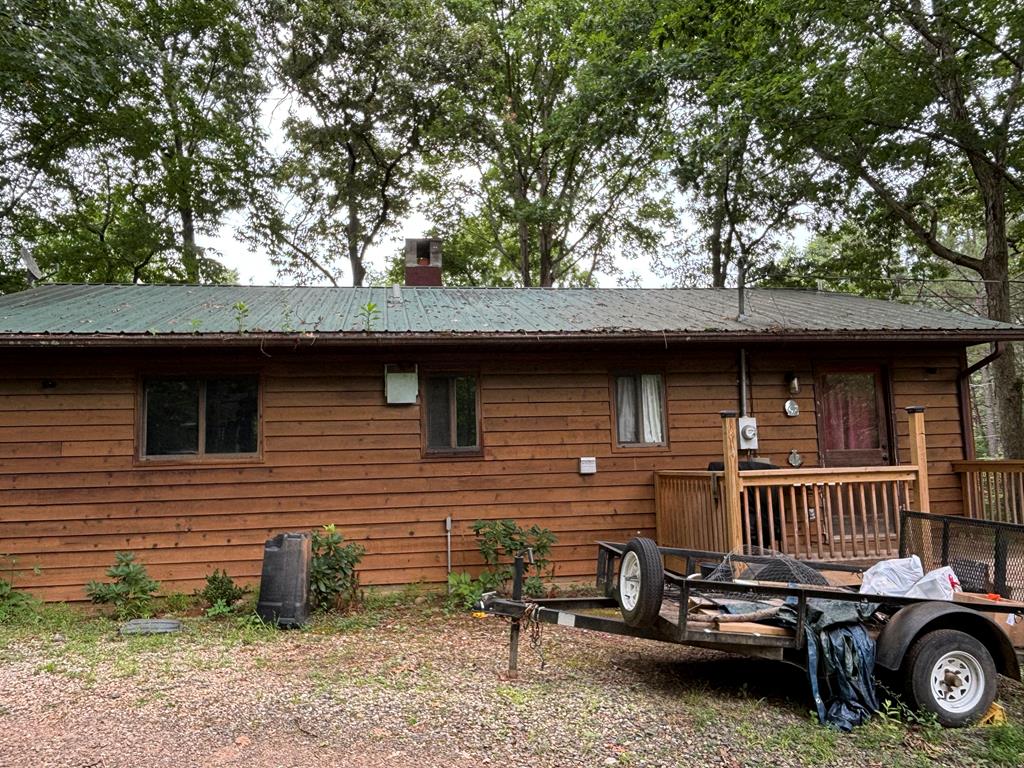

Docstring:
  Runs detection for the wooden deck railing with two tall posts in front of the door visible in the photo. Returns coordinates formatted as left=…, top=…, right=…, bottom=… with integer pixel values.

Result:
left=655, top=408, right=929, bottom=560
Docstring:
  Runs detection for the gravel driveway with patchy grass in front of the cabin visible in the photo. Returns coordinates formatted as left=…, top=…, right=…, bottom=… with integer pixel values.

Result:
left=0, top=598, right=1024, bottom=768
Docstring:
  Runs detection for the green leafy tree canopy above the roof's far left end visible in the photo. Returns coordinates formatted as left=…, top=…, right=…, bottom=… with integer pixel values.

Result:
left=0, top=0, right=265, bottom=283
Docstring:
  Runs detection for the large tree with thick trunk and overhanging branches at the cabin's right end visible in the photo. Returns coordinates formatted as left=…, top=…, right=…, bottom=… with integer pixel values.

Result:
left=662, top=0, right=1024, bottom=457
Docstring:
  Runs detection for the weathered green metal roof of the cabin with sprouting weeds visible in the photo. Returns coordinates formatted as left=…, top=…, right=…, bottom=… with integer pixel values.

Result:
left=0, top=285, right=1024, bottom=344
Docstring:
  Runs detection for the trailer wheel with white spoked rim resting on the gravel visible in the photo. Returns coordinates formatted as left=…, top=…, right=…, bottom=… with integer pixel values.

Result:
left=903, top=630, right=995, bottom=728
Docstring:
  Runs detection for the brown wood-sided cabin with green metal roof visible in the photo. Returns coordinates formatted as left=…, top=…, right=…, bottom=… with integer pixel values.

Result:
left=0, top=280, right=1024, bottom=600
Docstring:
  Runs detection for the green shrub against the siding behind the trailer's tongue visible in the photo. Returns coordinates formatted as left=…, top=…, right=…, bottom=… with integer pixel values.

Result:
left=473, top=520, right=557, bottom=597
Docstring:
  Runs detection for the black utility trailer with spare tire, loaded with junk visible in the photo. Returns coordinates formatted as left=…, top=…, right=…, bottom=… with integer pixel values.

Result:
left=479, top=538, right=1024, bottom=727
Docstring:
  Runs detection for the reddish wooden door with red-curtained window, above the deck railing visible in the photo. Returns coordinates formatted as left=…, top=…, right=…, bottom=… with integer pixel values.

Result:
left=817, top=369, right=891, bottom=467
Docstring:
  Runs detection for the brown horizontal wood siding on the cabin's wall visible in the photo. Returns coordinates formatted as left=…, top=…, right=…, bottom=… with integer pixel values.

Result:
left=0, top=346, right=963, bottom=600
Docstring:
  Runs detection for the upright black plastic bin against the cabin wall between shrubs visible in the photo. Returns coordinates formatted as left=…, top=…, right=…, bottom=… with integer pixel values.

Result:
left=256, top=532, right=312, bottom=627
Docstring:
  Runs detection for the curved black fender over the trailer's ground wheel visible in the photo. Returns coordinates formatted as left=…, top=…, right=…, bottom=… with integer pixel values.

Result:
left=874, top=600, right=1021, bottom=680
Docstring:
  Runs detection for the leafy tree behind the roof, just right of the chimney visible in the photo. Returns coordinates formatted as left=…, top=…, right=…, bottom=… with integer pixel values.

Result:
left=434, top=0, right=673, bottom=286
